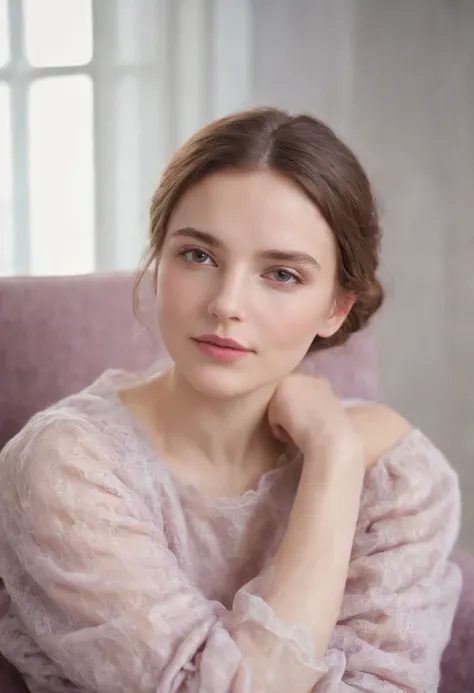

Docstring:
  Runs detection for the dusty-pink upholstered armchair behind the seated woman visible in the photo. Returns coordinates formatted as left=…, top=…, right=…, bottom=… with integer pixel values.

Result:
left=0, top=274, right=474, bottom=693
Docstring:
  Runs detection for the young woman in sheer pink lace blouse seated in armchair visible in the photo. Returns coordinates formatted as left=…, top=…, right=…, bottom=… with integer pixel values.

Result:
left=0, top=109, right=460, bottom=693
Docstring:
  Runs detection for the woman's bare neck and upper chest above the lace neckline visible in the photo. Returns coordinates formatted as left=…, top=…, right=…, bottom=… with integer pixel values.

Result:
left=125, top=367, right=282, bottom=475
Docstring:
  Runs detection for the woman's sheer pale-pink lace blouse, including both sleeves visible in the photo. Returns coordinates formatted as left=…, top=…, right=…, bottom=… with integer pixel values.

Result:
left=0, top=371, right=461, bottom=693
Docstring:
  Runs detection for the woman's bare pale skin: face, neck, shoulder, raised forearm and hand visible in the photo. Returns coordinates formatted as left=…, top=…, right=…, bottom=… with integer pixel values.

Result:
left=120, top=170, right=410, bottom=672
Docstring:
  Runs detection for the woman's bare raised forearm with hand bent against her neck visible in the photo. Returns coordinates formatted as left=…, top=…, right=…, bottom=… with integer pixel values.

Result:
left=266, top=373, right=392, bottom=657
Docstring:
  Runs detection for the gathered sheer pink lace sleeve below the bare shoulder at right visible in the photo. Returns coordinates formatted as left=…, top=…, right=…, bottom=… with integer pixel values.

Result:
left=315, top=430, right=461, bottom=693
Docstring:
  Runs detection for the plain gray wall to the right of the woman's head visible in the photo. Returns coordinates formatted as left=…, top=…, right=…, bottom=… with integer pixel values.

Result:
left=253, top=0, right=474, bottom=549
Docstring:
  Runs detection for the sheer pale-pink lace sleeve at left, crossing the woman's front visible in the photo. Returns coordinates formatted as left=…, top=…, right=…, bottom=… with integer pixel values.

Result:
left=0, top=421, right=325, bottom=693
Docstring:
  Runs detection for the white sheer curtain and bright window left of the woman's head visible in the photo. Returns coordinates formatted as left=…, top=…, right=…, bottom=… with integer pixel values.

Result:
left=0, top=0, right=252, bottom=275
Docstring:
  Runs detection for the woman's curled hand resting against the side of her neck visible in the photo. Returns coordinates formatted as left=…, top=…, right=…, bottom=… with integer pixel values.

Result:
left=268, top=373, right=364, bottom=464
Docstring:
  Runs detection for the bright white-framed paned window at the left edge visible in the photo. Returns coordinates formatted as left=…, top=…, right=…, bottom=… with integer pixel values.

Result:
left=0, top=0, right=95, bottom=274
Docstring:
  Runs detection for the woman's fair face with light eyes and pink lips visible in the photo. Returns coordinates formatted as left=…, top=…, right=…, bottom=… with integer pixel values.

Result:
left=157, top=170, right=347, bottom=398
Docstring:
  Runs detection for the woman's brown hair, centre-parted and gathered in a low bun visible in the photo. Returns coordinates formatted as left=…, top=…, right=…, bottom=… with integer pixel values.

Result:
left=134, top=108, right=383, bottom=351
